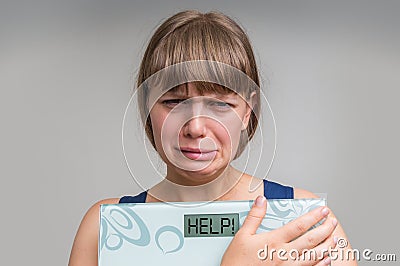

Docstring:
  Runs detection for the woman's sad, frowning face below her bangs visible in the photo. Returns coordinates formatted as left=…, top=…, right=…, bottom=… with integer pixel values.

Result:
left=150, top=83, right=251, bottom=185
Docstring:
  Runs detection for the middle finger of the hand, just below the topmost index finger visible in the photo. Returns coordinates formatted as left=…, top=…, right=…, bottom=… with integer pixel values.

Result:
left=289, top=217, right=338, bottom=251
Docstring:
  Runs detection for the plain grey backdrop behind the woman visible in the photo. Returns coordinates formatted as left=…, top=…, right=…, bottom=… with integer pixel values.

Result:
left=0, top=1, right=400, bottom=265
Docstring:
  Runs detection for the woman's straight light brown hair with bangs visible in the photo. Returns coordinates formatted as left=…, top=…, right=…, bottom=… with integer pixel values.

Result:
left=137, top=10, right=260, bottom=158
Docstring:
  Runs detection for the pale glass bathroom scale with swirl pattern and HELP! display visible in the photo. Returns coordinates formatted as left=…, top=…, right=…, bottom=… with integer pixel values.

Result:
left=99, top=199, right=326, bottom=266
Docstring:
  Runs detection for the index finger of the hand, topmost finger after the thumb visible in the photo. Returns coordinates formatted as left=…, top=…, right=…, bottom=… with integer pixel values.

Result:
left=275, top=207, right=329, bottom=242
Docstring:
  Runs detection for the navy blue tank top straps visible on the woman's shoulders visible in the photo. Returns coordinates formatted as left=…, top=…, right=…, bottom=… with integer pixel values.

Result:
left=119, top=179, right=294, bottom=203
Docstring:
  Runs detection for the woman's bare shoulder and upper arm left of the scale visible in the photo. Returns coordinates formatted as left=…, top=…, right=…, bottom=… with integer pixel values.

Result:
left=68, top=198, right=119, bottom=266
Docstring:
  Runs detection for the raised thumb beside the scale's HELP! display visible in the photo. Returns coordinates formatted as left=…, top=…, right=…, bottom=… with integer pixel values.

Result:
left=240, top=196, right=267, bottom=235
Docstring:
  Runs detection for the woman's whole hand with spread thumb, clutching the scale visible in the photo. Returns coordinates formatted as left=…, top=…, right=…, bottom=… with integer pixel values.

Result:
left=221, top=196, right=338, bottom=266
